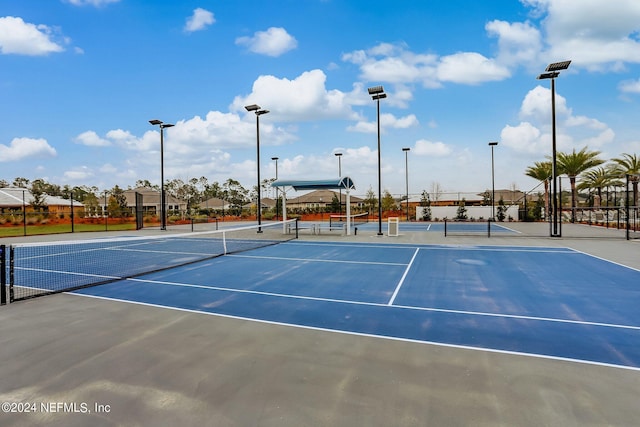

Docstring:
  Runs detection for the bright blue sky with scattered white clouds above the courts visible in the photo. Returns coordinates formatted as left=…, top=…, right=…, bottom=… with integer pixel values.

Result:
left=0, top=0, right=640, bottom=194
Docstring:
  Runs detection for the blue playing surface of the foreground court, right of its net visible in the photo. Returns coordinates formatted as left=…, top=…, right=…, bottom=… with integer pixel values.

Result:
left=76, top=241, right=640, bottom=369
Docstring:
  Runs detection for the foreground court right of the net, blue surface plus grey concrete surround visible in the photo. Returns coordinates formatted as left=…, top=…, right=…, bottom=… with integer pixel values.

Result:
left=0, top=223, right=640, bottom=426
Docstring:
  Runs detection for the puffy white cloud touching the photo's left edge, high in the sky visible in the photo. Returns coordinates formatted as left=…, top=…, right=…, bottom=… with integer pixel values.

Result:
left=0, top=16, right=64, bottom=56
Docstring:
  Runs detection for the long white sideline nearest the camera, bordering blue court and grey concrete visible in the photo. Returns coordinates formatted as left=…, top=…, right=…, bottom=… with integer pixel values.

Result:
left=74, top=294, right=640, bottom=372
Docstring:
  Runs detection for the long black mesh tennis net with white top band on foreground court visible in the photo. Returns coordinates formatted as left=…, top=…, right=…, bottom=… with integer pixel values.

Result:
left=0, top=219, right=298, bottom=304
